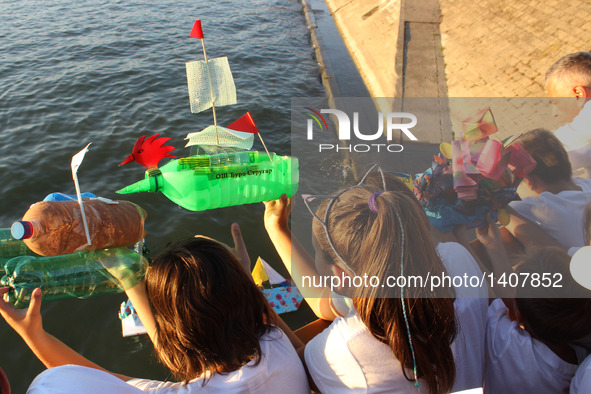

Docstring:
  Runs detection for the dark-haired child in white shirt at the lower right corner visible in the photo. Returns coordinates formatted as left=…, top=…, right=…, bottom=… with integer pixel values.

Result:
left=485, top=247, right=591, bottom=394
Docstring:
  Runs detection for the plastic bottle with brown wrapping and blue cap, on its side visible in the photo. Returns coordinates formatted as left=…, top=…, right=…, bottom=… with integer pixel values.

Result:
left=11, top=198, right=147, bottom=256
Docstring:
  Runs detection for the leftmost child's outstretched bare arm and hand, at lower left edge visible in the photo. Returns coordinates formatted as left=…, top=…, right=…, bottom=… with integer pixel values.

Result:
left=0, top=287, right=132, bottom=381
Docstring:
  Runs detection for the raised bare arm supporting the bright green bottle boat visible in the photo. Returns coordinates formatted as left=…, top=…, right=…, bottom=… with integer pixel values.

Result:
left=265, top=194, right=337, bottom=320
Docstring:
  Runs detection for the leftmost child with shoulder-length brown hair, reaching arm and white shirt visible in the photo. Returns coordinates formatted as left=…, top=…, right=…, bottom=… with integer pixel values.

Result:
left=0, top=226, right=310, bottom=393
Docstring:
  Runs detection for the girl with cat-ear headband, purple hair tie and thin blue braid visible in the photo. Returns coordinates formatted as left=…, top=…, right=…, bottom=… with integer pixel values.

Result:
left=265, top=166, right=488, bottom=394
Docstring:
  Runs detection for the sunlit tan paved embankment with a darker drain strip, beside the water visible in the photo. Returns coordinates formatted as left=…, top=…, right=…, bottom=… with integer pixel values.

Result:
left=325, top=0, right=591, bottom=143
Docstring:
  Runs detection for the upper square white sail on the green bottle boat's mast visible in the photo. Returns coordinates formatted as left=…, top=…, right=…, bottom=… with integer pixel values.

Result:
left=186, top=57, right=237, bottom=113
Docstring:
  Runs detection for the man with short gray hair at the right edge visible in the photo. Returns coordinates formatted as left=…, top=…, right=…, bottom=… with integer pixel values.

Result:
left=546, top=52, right=591, bottom=178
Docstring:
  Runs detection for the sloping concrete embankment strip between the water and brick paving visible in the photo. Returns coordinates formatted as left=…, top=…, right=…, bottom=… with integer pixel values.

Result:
left=312, top=0, right=452, bottom=143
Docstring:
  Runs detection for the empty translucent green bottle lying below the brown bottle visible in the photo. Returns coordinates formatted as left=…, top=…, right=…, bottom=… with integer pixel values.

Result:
left=0, top=248, right=147, bottom=308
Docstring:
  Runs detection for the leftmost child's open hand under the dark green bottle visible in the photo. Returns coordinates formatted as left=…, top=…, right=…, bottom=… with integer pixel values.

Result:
left=0, top=287, right=43, bottom=338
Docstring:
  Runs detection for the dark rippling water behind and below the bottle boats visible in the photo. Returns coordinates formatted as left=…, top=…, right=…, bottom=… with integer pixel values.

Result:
left=0, top=0, right=324, bottom=393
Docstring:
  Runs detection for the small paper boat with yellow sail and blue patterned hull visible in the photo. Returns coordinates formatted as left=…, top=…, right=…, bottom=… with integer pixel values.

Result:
left=252, top=257, right=304, bottom=314
